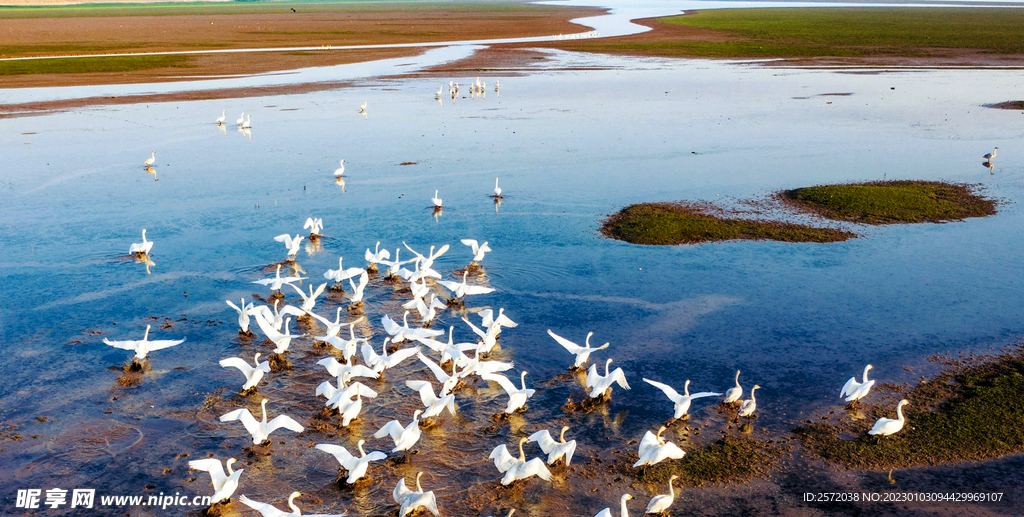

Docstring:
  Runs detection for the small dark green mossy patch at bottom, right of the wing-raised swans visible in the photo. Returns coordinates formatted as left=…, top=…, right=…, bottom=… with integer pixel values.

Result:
left=612, top=435, right=791, bottom=486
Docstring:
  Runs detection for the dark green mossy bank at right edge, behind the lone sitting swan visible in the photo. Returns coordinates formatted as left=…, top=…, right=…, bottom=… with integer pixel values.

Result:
left=794, top=350, right=1024, bottom=469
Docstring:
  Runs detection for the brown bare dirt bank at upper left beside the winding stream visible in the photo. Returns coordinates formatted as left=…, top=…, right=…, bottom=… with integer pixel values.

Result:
left=0, top=2, right=604, bottom=88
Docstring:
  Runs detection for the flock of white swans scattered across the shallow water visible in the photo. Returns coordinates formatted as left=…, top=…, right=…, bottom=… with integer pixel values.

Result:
left=97, top=90, right=913, bottom=517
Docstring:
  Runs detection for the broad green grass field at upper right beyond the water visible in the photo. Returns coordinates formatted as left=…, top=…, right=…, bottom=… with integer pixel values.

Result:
left=588, top=7, right=1024, bottom=57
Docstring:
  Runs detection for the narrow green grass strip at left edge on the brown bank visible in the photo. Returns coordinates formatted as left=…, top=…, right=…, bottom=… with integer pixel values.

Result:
left=0, top=55, right=188, bottom=76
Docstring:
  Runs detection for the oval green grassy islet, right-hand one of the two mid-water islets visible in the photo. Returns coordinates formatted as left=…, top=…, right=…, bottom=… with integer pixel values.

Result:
left=780, top=180, right=995, bottom=224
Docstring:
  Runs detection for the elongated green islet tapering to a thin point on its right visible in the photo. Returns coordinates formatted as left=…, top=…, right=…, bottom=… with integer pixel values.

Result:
left=601, top=203, right=857, bottom=245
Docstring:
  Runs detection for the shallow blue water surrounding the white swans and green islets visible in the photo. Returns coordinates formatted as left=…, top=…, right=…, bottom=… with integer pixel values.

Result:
left=0, top=52, right=1024, bottom=515
